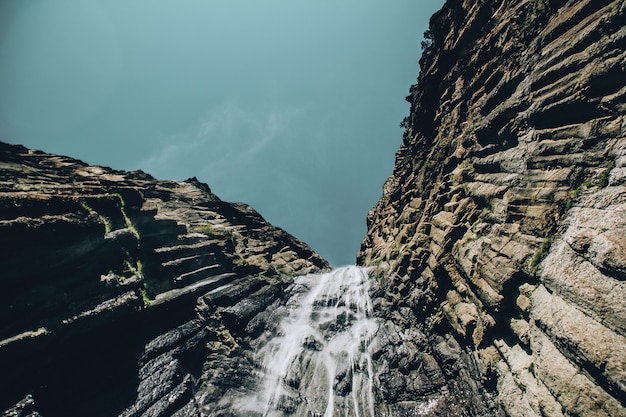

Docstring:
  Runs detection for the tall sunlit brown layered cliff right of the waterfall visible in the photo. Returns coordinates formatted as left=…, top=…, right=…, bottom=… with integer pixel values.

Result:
left=358, top=0, right=626, bottom=416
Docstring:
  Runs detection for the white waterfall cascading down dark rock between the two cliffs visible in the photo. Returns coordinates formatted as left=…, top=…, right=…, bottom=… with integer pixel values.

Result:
left=239, top=266, right=378, bottom=417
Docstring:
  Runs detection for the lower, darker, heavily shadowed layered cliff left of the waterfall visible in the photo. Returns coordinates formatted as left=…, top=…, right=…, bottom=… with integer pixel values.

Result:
left=0, top=143, right=328, bottom=417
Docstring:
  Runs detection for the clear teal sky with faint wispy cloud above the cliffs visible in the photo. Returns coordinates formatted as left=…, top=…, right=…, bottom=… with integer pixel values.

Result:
left=0, top=0, right=443, bottom=266
